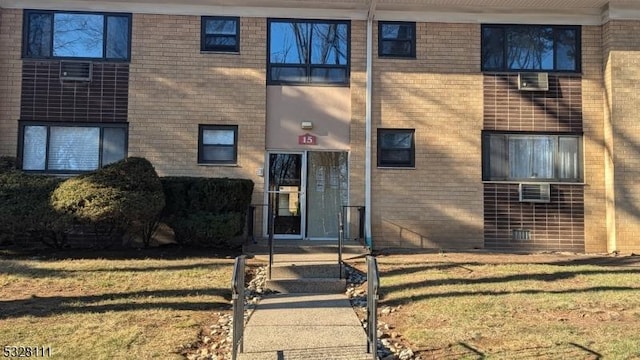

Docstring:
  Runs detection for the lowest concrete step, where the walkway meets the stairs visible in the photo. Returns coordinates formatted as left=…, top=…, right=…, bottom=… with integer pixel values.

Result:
left=266, top=276, right=347, bottom=294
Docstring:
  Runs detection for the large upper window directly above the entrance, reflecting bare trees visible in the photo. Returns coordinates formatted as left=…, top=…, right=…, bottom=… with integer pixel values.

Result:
left=268, top=20, right=350, bottom=84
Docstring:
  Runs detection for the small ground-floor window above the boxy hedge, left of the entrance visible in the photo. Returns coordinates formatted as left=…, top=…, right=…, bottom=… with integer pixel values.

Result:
left=198, top=125, right=238, bottom=164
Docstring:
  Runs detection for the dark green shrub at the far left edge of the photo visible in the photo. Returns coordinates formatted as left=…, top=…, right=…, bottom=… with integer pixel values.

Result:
left=0, top=171, right=70, bottom=248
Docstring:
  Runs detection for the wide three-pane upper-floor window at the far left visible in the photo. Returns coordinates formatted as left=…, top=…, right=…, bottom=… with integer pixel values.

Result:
left=23, top=10, right=131, bottom=60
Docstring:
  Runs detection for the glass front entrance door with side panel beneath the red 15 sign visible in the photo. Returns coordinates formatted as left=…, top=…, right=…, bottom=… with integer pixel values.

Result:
left=265, top=151, right=349, bottom=240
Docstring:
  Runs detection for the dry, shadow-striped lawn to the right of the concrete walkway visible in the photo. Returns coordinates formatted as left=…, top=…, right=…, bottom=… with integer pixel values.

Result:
left=368, top=254, right=640, bottom=359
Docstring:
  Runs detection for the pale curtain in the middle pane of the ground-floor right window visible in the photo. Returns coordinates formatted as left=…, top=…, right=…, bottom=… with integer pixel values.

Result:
left=509, top=137, right=555, bottom=179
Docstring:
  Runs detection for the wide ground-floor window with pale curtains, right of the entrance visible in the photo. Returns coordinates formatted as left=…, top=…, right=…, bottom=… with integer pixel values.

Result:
left=482, top=133, right=582, bottom=182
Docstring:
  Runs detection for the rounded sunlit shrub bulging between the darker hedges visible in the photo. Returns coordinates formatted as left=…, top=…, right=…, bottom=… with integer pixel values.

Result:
left=51, top=157, right=165, bottom=245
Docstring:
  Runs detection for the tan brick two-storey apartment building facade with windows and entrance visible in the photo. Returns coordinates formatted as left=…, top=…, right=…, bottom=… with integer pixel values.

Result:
left=0, top=0, right=640, bottom=252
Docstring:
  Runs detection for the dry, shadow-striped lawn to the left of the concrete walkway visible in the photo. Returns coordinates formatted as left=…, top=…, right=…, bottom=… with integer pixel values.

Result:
left=0, top=250, right=233, bottom=359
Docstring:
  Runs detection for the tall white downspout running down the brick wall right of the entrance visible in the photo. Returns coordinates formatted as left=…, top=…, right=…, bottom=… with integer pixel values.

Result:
left=364, top=0, right=377, bottom=251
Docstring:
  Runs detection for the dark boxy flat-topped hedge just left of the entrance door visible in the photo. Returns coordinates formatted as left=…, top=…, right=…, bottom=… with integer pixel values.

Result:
left=161, top=177, right=254, bottom=247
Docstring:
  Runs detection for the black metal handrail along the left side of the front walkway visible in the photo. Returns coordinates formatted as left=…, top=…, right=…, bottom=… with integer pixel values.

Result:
left=231, top=255, right=247, bottom=360
